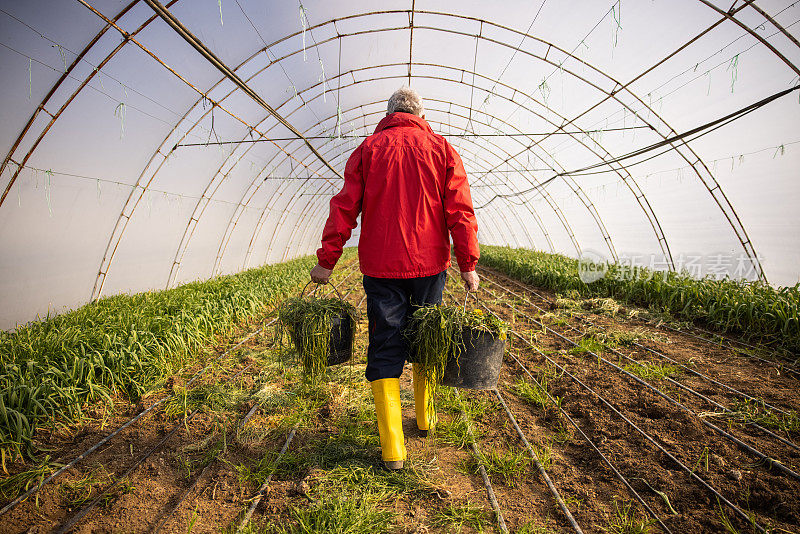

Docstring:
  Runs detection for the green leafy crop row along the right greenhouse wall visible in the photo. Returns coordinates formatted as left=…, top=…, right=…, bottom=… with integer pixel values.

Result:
left=481, top=246, right=800, bottom=354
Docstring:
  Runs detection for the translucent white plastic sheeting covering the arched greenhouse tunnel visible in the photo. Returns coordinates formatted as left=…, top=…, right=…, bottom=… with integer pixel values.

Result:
left=0, top=0, right=800, bottom=329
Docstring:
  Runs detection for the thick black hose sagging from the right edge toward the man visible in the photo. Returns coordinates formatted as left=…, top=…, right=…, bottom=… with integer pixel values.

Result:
left=475, top=85, right=800, bottom=210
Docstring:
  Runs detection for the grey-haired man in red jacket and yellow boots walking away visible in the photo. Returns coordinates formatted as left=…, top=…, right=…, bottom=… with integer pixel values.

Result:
left=311, top=87, right=479, bottom=469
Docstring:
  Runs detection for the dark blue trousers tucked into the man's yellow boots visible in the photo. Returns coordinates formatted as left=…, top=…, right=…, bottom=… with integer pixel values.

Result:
left=364, top=271, right=447, bottom=382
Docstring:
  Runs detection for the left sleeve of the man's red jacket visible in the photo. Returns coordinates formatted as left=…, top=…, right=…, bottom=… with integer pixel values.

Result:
left=317, top=146, right=364, bottom=269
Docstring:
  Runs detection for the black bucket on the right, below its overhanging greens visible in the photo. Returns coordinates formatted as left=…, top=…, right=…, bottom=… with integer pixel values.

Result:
left=442, top=328, right=506, bottom=389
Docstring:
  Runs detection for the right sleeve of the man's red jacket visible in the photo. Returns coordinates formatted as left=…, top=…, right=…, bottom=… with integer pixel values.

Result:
left=444, top=140, right=480, bottom=272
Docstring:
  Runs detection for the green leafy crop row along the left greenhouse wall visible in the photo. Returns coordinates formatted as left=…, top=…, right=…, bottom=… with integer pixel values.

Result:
left=0, top=253, right=351, bottom=462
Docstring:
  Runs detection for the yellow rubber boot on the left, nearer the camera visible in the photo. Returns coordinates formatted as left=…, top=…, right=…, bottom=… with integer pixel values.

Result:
left=370, top=378, right=406, bottom=469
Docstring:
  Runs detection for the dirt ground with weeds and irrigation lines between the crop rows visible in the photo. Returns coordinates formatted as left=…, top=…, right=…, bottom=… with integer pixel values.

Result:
left=0, top=264, right=800, bottom=534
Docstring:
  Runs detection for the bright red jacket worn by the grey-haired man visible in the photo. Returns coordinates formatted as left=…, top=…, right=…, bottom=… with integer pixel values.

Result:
left=317, top=112, right=479, bottom=278
